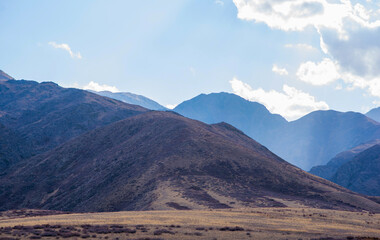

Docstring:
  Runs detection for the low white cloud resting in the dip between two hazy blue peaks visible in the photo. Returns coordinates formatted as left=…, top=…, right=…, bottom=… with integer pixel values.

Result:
left=230, top=78, right=329, bottom=120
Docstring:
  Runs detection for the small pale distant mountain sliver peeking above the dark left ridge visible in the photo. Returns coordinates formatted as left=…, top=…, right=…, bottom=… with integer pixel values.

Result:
left=91, top=91, right=167, bottom=111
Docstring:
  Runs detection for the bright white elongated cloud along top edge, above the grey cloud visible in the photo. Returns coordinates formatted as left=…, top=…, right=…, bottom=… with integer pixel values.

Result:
left=233, top=0, right=380, bottom=38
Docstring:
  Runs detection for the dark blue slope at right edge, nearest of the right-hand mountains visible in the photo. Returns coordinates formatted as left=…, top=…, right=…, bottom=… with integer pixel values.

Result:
left=331, top=144, right=380, bottom=196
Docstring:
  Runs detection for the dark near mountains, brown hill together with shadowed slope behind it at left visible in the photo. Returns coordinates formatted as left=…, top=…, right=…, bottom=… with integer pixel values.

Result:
left=0, top=72, right=380, bottom=212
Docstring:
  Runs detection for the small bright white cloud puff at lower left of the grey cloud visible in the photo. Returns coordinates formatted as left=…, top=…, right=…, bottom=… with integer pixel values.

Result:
left=296, top=58, right=340, bottom=86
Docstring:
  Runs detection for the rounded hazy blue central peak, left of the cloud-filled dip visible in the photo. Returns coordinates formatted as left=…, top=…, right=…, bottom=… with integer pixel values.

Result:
left=173, top=92, right=287, bottom=149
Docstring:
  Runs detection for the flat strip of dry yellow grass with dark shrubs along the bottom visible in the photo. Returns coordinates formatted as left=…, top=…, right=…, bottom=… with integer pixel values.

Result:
left=0, top=208, right=380, bottom=239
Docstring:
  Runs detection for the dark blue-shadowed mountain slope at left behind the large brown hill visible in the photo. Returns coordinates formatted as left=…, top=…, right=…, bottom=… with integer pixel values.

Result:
left=0, top=80, right=148, bottom=153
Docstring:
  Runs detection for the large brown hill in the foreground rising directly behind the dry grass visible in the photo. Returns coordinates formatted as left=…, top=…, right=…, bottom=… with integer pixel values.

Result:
left=0, top=112, right=380, bottom=212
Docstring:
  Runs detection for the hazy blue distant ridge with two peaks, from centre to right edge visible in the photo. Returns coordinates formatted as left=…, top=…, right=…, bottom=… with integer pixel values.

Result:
left=174, top=93, right=380, bottom=170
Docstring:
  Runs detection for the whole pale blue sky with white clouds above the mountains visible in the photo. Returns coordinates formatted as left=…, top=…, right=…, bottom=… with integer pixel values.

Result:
left=0, top=0, right=380, bottom=120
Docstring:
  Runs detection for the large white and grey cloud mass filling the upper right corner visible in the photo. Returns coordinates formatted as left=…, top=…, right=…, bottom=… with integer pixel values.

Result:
left=233, top=0, right=380, bottom=97
